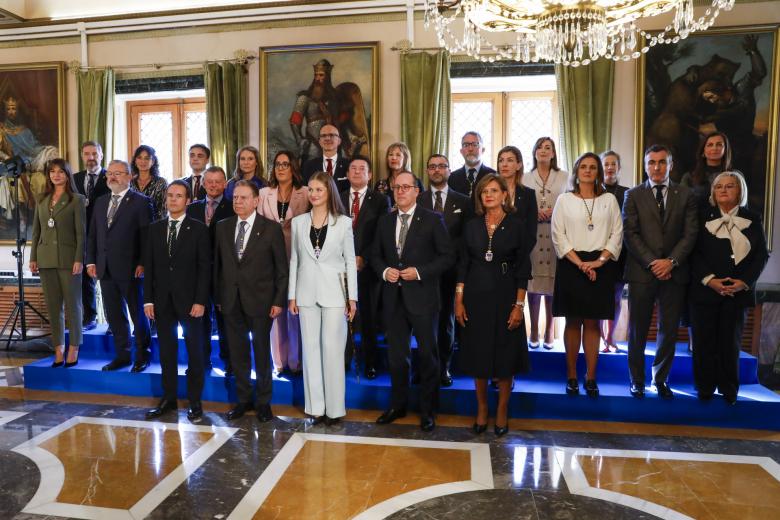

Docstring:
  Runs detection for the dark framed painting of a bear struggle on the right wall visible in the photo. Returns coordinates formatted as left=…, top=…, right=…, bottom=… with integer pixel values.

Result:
left=636, top=25, right=780, bottom=244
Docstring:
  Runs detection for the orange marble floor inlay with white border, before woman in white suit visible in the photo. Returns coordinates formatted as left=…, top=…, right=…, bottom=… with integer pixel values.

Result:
left=229, top=433, right=493, bottom=520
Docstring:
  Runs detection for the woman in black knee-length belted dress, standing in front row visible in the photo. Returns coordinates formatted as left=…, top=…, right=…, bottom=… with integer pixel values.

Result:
left=455, top=175, right=531, bottom=436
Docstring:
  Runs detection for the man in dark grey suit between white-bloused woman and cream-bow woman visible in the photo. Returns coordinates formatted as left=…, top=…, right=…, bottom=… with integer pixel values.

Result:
left=623, top=145, right=698, bottom=399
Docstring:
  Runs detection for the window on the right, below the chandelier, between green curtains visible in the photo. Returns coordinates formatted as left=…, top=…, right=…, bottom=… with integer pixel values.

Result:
left=449, top=76, right=562, bottom=171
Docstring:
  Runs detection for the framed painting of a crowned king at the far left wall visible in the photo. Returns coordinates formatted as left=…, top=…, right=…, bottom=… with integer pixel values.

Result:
left=0, top=62, right=66, bottom=243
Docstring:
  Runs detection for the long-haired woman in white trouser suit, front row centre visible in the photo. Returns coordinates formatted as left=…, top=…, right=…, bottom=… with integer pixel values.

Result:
left=288, top=172, right=357, bottom=425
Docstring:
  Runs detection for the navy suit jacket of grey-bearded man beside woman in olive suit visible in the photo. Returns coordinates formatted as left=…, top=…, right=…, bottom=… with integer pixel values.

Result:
left=86, top=189, right=154, bottom=281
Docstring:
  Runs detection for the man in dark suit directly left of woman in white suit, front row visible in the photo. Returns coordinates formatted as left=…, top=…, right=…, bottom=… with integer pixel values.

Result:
left=214, top=181, right=290, bottom=422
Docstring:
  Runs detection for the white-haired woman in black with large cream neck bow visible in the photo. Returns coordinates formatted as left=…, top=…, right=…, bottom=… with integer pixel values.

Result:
left=688, top=171, right=769, bottom=404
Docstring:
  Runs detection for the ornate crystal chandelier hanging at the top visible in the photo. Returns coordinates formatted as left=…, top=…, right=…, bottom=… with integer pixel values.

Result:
left=425, top=0, right=734, bottom=67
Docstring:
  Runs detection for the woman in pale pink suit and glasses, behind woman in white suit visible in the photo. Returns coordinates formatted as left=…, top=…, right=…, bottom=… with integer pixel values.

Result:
left=257, top=150, right=309, bottom=375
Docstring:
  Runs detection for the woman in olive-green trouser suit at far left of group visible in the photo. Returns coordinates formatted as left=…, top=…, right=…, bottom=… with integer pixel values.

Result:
left=30, top=159, right=86, bottom=367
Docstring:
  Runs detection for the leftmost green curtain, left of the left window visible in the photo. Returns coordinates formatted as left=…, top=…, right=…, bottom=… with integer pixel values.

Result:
left=78, top=68, right=114, bottom=169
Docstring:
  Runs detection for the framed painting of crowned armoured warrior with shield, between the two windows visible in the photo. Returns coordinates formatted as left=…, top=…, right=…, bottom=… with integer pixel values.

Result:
left=260, top=42, right=379, bottom=170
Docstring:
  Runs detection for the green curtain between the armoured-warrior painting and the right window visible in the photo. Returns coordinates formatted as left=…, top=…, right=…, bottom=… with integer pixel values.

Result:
left=401, top=51, right=451, bottom=184
